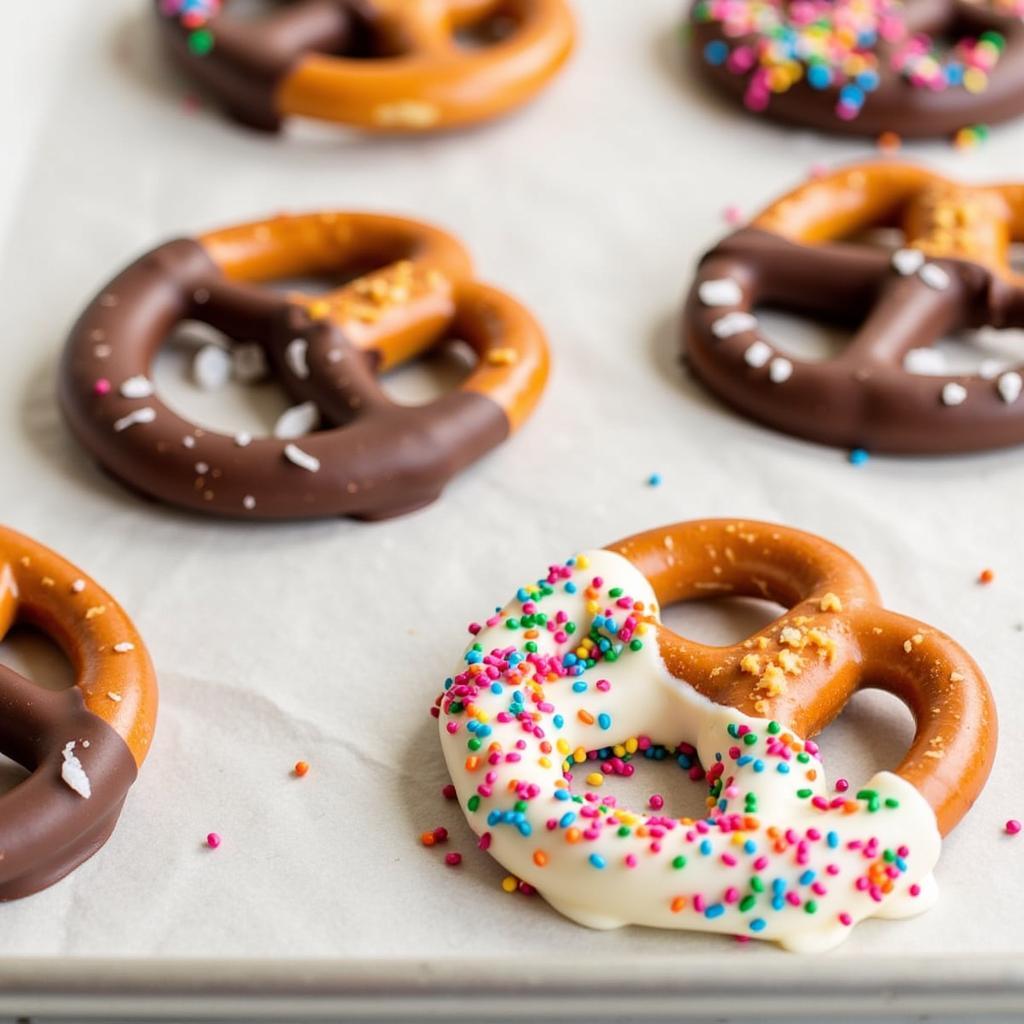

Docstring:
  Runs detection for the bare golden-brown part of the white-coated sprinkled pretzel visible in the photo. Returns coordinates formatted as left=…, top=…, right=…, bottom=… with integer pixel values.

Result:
left=609, top=519, right=996, bottom=835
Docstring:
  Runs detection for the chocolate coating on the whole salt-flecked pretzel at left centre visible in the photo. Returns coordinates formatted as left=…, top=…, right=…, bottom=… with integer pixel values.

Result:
left=59, top=240, right=510, bottom=519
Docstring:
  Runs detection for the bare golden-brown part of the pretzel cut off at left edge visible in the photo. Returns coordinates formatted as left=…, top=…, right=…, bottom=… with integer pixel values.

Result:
left=0, top=526, right=157, bottom=765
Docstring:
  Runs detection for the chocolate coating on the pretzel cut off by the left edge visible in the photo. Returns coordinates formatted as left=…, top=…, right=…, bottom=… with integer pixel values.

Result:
left=0, top=665, right=137, bottom=900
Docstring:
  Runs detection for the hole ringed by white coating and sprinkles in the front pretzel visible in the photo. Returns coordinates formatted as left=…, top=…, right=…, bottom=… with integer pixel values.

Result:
left=569, top=743, right=708, bottom=818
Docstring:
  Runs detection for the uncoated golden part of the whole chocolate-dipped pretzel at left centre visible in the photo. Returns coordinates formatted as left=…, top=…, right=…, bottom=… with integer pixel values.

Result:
left=198, top=213, right=549, bottom=431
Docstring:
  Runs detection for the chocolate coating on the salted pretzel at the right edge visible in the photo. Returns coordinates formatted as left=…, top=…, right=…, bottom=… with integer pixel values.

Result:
left=683, top=227, right=1024, bottom=455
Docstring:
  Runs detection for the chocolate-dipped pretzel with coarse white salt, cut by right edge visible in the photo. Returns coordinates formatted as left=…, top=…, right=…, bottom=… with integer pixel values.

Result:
left=683, top=162, right=1024, bottom=454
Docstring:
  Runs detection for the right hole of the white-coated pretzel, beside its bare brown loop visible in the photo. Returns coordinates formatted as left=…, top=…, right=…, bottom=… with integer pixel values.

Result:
left=815, top=689, right=914, bottom=788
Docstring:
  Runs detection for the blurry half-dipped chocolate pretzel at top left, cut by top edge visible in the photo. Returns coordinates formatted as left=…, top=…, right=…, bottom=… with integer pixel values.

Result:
left=156, top=0, right=575, bottom=133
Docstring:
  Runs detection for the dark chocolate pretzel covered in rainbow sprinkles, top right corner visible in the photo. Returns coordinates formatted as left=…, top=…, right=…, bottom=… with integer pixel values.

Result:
left=691, top=0, right=1024, bottom=138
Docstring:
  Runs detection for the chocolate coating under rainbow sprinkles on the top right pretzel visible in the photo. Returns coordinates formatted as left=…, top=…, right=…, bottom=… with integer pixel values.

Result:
left=691, top=0, right=1024, bottom=138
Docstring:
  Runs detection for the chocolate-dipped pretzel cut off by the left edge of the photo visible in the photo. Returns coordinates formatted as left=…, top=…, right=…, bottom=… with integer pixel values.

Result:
left=0, top=527, right=157, bottom=900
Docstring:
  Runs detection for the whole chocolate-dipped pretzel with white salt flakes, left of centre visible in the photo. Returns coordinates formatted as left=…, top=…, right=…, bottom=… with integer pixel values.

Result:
left=60, top=213, right=548, bottom=519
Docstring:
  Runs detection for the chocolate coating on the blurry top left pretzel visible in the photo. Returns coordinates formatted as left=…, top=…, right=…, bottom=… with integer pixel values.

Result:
left=151, top=0, right=367, bottom=131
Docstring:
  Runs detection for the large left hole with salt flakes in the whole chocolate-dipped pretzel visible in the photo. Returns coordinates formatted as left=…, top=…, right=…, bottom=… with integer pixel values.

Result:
left=152, top=321, right=303, bottom=437
